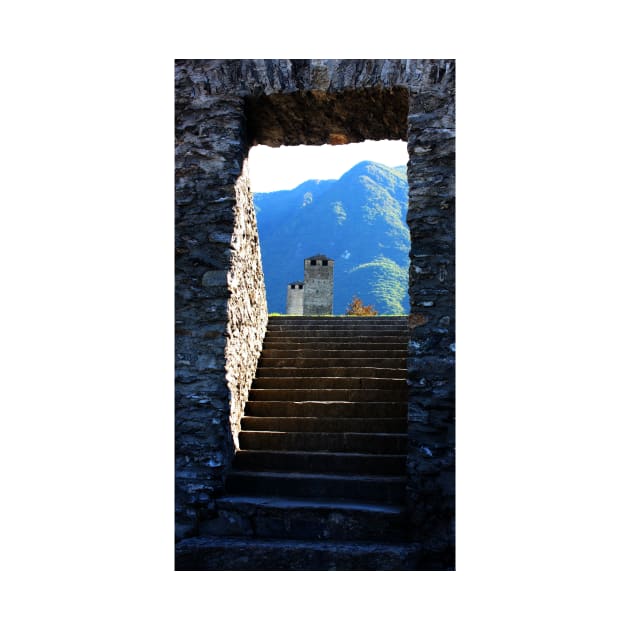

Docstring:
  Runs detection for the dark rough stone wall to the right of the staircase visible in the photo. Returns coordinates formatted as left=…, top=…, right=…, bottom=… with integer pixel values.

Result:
left=407, top=63, right=455, bottom=564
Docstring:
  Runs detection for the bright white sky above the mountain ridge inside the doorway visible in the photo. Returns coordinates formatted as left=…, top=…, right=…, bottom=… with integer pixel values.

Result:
left=249, top=140, right=409, bottom=192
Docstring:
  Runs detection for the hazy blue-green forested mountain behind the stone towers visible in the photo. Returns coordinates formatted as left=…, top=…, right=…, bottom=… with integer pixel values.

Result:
left=254, top=162, right=410, bottom=314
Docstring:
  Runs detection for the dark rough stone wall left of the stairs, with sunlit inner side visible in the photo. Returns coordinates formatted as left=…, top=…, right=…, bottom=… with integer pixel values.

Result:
left=175, top=86, right=266, bottom=538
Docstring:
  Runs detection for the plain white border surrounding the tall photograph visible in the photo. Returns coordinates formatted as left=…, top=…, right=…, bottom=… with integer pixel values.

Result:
left=0, top=1, right=630, bottom=630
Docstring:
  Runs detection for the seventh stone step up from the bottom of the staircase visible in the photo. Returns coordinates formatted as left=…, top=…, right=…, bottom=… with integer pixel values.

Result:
left=245, top=400, right=407, bottom=418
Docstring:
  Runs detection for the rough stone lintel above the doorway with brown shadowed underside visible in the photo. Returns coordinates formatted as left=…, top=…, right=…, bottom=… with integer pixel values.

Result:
left=175, top=59, right=414, bottom=146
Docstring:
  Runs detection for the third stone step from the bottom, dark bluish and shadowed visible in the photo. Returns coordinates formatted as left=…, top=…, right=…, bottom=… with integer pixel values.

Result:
left=226, top=470, right=407, bottom=504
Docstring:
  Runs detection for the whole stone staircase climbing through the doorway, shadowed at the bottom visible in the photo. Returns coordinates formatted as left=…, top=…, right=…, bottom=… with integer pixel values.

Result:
left=177, top=317, right=428, bottom=570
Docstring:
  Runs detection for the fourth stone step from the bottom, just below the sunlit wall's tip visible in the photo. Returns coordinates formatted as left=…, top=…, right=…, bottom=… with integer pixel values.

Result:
left=232, top=450, right=407, bottom=475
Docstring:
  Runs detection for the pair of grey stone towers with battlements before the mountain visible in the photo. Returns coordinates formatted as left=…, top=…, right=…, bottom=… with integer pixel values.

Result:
left=287, top=254, right=335, bottom=315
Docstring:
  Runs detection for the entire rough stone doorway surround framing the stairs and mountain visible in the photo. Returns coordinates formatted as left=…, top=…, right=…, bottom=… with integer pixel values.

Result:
left=175, top=59, right=455, bottom=567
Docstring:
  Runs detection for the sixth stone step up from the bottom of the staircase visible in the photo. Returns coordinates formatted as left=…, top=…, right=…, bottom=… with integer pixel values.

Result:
left=241, top=416, right=407, bottom=433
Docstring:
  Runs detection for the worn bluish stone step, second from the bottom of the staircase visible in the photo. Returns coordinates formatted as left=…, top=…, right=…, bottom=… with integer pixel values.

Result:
left=199, top=496, right=408, bottom=542
